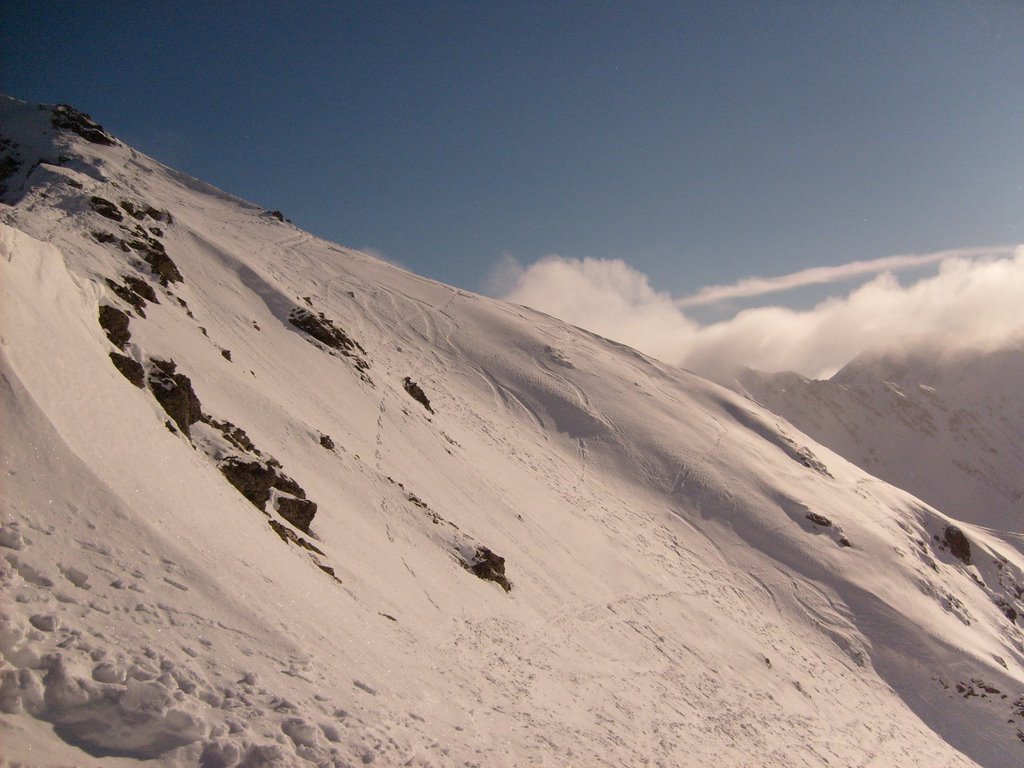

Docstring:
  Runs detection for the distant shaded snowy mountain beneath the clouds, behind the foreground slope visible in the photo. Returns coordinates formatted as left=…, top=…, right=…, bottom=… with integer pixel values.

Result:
left=737, top=342, right=1024, bottom=546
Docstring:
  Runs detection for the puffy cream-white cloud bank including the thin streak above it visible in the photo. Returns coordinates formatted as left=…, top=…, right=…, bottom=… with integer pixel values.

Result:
left=498, top=246, right=1024, bottom=380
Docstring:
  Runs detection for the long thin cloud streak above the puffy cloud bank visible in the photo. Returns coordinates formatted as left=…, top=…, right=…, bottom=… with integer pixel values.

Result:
left=676, top=246, right=1014, bottom=307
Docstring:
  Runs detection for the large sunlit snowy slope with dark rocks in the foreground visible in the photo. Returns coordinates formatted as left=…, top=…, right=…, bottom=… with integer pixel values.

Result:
left=0, top=100, right=1024, bottom=768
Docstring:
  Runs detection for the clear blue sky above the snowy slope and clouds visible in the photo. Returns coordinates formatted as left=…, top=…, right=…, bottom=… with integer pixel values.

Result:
left=0, top=0, right=1024, bottom=295
